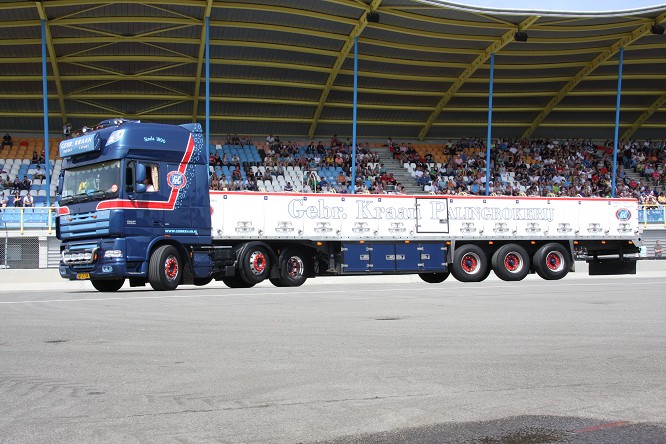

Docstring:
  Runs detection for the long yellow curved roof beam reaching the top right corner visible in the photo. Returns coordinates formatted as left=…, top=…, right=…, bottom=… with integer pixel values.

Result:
left=522, top=12, right=666, bottom=139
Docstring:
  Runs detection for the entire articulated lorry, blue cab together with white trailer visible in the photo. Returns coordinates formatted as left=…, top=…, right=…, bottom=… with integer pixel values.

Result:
left=56, top=120, right=640, bottom=292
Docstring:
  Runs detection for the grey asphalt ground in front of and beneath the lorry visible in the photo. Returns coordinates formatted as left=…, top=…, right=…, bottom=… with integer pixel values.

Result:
left=0, top=261, right=666, bottom=444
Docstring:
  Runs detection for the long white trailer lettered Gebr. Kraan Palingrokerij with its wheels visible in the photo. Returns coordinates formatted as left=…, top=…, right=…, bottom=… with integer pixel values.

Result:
left=210, top=191, right=640, bottom=287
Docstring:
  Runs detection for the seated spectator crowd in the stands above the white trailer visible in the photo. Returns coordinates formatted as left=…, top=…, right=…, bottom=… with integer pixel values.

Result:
left=210, top=134, right=666, bottom=205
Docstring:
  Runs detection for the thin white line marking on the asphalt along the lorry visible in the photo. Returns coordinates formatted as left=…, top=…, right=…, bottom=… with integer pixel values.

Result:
left=0, top=282, right=654, bottom=305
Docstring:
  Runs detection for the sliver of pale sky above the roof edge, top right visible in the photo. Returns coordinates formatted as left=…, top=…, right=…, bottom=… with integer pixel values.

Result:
left=451, top=0, right=666, bottom=12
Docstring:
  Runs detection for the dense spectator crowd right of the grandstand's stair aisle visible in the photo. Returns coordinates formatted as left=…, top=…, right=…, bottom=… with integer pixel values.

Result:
left=394, top=139, right=666, bottom=203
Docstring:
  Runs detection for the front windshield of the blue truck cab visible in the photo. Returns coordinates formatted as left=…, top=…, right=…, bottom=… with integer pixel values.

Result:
left=60, top=160, right=121, bottom=205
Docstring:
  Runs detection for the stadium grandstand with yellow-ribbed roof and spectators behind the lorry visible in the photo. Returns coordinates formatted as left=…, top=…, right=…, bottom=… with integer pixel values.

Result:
left=0, top=0, right=666, bottom=267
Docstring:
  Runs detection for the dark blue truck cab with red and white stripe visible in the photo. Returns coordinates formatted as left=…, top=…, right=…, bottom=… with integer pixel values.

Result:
left=56, top=119, right=211, bottom=291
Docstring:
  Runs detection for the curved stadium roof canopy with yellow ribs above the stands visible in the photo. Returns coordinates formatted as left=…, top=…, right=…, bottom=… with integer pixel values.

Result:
left=0, top=0, right=666, bottom=139
